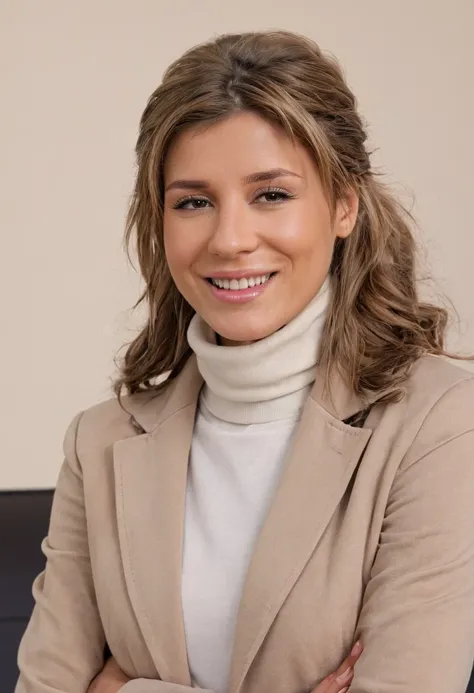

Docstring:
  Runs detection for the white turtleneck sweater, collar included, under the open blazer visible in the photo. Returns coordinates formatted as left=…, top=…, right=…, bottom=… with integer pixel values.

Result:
left=182, top=282, right=329, bottom=693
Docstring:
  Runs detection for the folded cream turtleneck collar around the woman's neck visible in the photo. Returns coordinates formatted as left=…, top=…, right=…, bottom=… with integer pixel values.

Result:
left=188, top=279, right=330, bottom=424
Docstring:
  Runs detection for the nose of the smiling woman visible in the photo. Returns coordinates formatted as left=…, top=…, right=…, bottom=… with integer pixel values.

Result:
left=208, top=203, right=259, bottom=259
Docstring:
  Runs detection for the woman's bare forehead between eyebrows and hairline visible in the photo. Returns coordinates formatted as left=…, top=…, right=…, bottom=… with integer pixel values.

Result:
left=164, top=112, right=314, bottom=180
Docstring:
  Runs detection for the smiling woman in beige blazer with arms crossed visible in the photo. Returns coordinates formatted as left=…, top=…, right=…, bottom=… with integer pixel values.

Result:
left=16, top=32, right=474, bottom=693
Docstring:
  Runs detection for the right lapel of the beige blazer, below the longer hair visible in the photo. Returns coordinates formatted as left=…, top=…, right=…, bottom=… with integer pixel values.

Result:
left=229, top=377, right=371, bottom=693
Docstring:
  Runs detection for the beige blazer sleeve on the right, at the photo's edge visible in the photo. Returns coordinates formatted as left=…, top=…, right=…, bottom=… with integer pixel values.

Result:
left=350, top=380, right=474, bottom=693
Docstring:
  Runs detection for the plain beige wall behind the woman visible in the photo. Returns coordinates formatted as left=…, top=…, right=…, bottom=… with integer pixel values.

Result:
left=0, top=0, right=474, bottom=488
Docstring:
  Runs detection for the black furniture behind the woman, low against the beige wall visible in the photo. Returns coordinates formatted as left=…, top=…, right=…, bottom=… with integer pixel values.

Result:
left=0, top=491, right=474, bottom=693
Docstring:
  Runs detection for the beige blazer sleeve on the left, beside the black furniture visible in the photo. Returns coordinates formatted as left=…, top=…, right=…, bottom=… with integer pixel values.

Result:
left=15, top=412, right=214, bottom=693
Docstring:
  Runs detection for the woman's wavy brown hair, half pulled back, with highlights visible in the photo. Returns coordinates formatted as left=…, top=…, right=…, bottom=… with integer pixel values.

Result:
left=114, top=31, right=458, bottom=401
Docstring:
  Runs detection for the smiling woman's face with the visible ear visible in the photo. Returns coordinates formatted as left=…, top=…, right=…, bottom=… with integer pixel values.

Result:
left=164, top=112, right=357, bottom=346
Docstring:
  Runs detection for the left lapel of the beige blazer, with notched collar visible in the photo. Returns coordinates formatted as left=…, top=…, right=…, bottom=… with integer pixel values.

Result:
left=113, top=358, right=202, bottom=686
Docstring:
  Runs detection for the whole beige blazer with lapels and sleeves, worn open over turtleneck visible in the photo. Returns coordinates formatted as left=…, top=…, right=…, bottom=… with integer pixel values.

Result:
left=16, top=357, right=474, bottom=693
